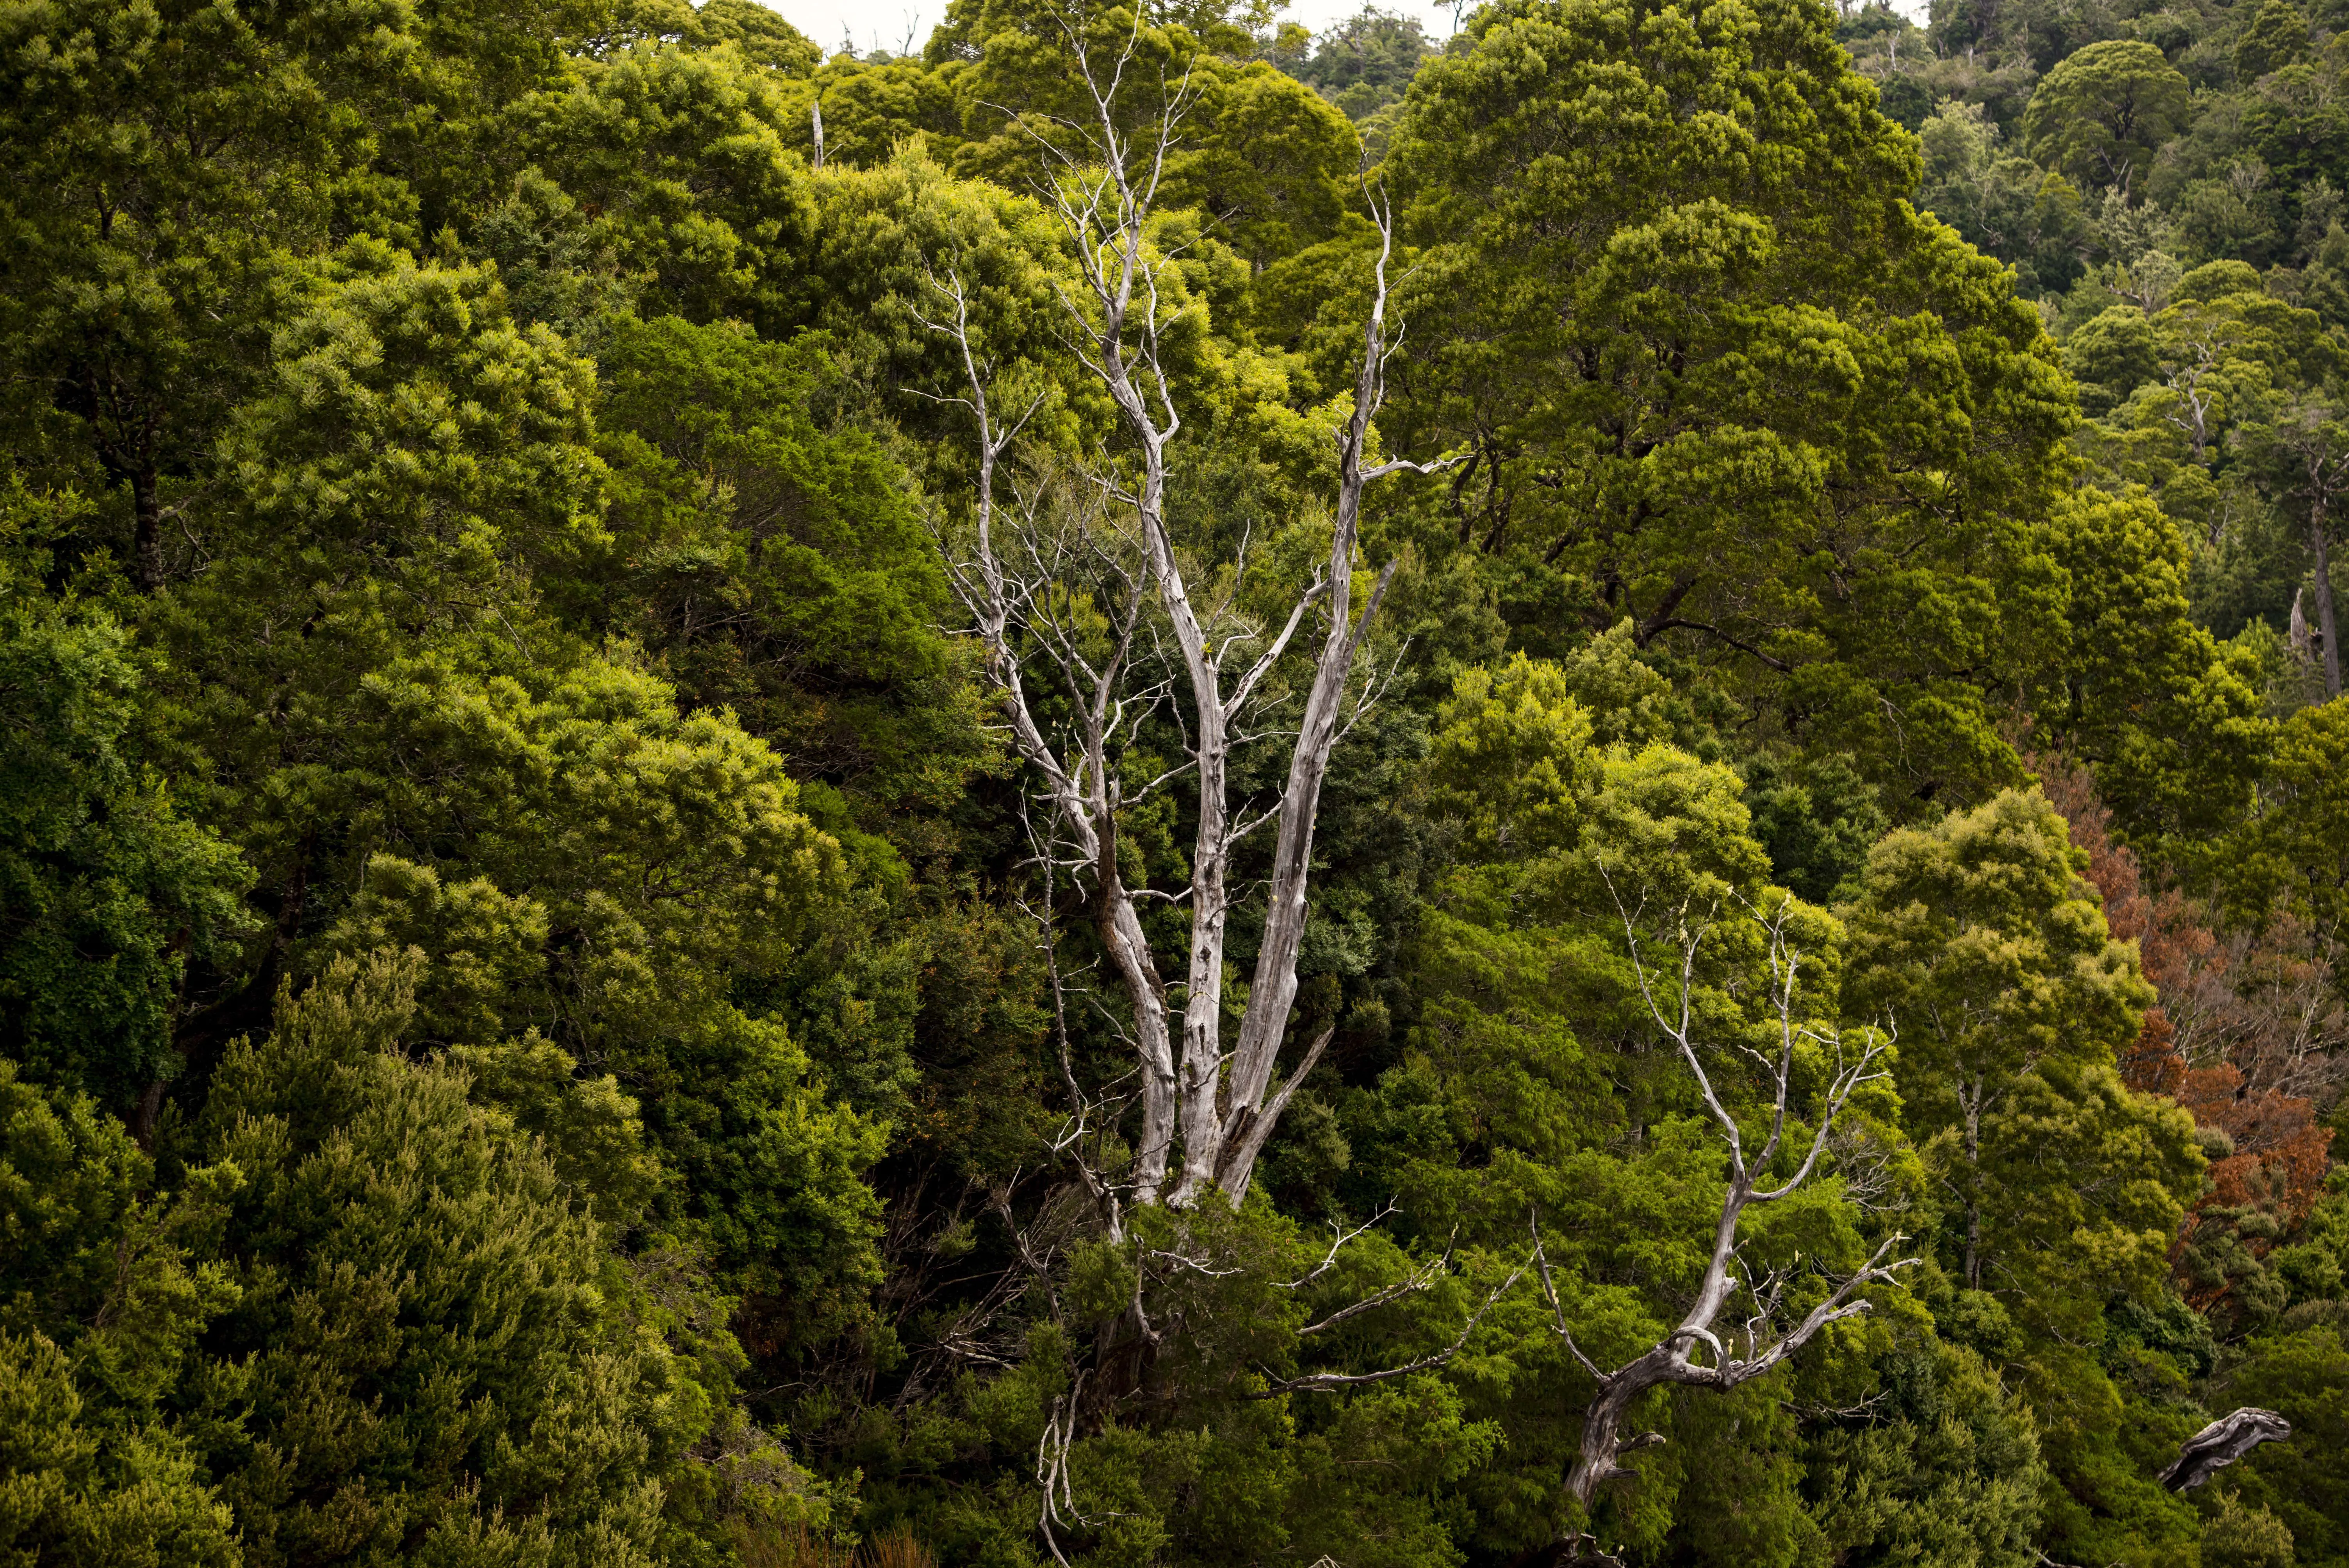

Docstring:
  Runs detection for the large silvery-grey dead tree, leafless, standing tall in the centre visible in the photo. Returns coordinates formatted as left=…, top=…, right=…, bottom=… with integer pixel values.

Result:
left=925, top=19, right=1445, bottom=1206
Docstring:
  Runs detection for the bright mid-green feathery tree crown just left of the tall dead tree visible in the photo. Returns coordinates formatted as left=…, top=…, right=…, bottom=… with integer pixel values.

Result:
left=594, top=317, right=987, bottom=824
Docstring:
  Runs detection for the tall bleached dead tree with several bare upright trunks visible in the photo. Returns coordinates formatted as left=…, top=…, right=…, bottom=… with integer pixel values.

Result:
left=930, top=40, right=1445, bottom=1206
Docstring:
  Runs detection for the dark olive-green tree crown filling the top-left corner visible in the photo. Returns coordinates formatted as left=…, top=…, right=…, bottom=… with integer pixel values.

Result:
left=0, top=0, right=404, bottom=587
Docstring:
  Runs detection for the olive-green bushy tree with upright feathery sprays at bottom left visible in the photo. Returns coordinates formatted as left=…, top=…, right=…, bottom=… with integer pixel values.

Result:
left=188, top=960, right=709, bottom=1561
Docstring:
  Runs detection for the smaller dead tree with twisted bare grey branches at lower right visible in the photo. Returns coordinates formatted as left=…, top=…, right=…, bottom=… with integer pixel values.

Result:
left=1534, top=880, right=1914, bottom=1545
